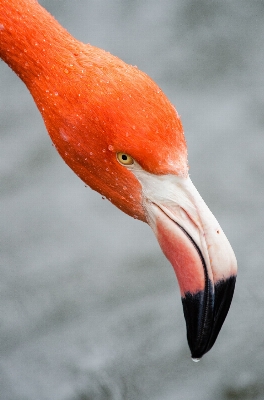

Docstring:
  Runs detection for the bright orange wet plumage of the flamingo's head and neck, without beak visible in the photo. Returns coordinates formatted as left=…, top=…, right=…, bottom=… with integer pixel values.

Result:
left=0, top=0, right=188, bottom=221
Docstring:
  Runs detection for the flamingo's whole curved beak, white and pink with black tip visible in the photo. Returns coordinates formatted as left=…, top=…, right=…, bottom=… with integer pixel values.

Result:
left=140, top=175, right=237, bottom=359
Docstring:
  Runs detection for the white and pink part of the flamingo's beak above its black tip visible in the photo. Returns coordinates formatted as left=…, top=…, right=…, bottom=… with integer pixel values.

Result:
left=133, top=170, right=237, bottom=295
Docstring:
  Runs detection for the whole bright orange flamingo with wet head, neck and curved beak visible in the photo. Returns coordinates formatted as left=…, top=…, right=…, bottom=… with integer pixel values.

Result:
left=0, top=0, right=237, bottom=359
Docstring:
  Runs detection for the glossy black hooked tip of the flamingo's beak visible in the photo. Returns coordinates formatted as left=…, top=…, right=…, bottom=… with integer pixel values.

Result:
left=182, top=276, right=236, bottom=360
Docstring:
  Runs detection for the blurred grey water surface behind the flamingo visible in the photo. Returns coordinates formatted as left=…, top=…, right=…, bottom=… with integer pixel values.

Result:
left=0, top=0, right=264, bottom=400
